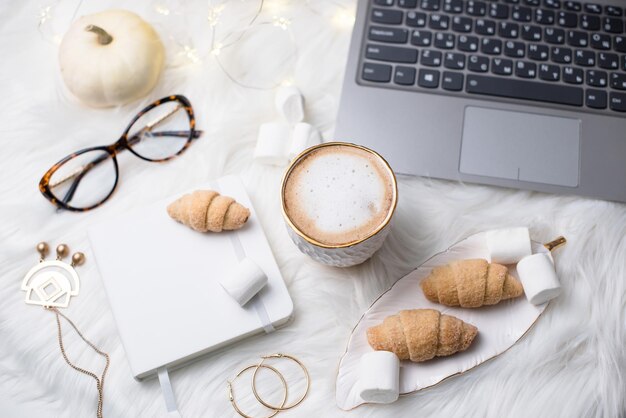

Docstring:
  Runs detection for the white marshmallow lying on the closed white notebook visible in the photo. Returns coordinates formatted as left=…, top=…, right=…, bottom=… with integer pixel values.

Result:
left=220, top=258, right=267, bottom=306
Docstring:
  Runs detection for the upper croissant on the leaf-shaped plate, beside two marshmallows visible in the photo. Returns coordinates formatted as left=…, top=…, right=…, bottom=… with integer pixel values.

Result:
left=420, top=259, right=524, bottom=308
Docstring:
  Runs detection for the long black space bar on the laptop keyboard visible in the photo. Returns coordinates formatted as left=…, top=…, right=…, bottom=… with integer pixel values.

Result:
left=465, top=74, right=584, bottom=106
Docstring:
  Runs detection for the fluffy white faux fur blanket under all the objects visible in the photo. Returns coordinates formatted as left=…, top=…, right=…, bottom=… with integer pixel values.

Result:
left=0, top=0, right=626, bottom=418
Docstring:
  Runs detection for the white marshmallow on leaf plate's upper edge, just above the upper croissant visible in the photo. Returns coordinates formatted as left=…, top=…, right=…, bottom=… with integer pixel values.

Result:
left=487, top=227, right=532, bottom=264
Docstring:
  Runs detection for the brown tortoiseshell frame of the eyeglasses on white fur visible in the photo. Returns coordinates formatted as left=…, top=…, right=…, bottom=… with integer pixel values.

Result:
left=39, top=95, right=202, bottom=212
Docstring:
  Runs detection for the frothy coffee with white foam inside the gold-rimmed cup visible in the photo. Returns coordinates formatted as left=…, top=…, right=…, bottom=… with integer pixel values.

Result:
left=283, top=144, right=395, bottom=246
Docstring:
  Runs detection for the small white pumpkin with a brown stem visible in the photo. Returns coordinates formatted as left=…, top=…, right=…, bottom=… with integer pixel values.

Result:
left=59, top=10, right=165, bottom=107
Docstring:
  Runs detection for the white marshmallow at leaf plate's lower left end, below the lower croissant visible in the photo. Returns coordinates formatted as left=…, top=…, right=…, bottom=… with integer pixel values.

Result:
left=358, top=351, right=400, bottom=403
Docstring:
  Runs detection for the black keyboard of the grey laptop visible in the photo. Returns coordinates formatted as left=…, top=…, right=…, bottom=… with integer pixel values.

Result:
left=359, top=0, right=626, bottom=116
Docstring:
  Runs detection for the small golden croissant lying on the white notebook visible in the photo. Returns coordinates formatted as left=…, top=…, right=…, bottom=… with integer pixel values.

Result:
left=167, top=190, right=250, bottom=232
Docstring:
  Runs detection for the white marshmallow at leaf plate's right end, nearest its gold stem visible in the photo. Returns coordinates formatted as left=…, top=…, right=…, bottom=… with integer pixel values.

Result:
left=517, top=253, right=561, bottom=305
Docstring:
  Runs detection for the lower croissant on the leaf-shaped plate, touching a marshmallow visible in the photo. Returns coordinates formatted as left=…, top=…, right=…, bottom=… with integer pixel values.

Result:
left=367, top=309, right=478, bottom=362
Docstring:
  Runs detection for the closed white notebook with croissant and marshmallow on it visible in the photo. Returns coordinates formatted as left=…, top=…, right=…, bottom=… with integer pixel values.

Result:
left=88, top=176, right=293, bottom=379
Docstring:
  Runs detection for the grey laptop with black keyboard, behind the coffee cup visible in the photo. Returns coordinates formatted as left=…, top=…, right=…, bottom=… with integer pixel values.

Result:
left=335, top=0, right=626, bottom=202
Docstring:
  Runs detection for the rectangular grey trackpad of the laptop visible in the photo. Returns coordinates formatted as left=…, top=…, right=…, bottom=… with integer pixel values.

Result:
left=460, top=107, right=580, bottom=187
